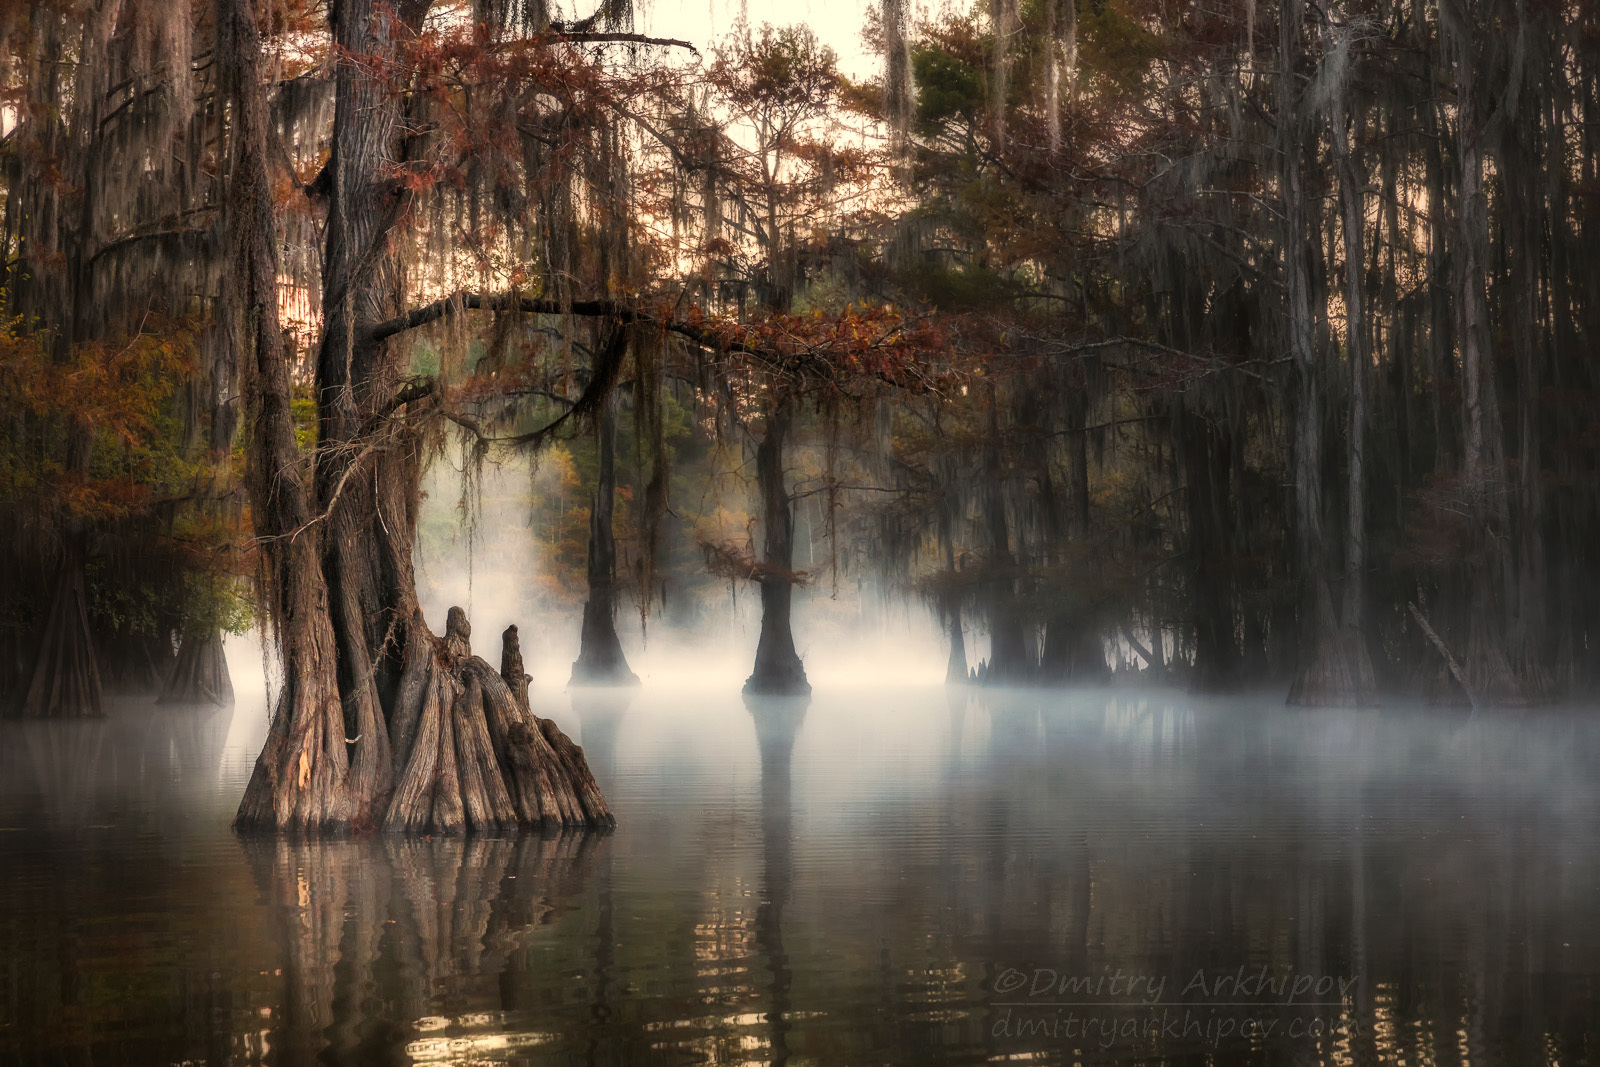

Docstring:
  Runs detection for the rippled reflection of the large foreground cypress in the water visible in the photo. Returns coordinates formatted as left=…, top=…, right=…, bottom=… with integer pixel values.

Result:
left=243, top=833, right=605, bottom=1062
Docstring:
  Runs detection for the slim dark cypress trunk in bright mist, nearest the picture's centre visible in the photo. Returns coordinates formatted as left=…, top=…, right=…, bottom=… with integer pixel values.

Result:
left=744, top=400, right=811, bottom=696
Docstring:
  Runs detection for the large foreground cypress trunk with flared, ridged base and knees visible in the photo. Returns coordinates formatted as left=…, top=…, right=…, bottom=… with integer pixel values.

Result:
left=218, top=0, right=611, bottom=832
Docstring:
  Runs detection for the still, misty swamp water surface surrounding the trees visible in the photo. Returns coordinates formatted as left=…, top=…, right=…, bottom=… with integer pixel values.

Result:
left=0, top=686, right=1600, bottom=1065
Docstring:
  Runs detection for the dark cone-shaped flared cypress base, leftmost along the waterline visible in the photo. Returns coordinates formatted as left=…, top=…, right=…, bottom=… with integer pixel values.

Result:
left=18, top=531, right=104, bottom=718
